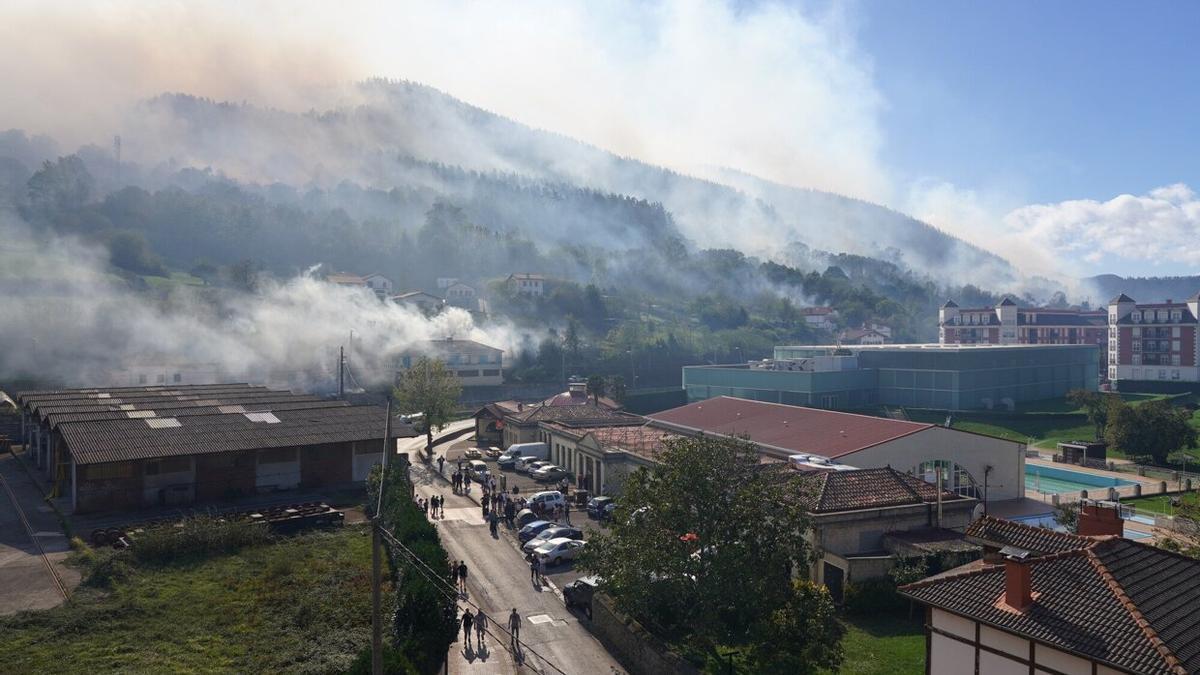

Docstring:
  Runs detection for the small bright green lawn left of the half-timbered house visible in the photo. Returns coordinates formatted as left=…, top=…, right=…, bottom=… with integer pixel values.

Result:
left=839, top=609, right=925, bottom=675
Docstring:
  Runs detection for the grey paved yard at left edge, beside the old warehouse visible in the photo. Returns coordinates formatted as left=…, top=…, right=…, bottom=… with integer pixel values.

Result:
left=0, top=452, right=79, bottom=615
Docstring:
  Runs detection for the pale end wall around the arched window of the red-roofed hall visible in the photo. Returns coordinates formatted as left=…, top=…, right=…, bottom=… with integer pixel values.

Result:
left=838, top=426, right=1025, bottom=502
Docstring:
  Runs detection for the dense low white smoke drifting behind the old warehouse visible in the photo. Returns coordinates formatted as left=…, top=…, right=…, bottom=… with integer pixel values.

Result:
left=0, top=212, right=516, bottom=388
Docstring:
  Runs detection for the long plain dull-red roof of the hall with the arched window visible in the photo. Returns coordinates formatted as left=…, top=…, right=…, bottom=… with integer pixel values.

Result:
left=649, top=396, right=934, bottom=459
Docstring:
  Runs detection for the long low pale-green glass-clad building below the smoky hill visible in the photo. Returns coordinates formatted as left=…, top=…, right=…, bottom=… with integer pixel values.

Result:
left=683, top=345, right=1100, bottom=410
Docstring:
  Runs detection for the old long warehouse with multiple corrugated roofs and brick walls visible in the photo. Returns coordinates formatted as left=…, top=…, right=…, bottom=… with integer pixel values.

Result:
left=17, top=384, right=415, bottom=513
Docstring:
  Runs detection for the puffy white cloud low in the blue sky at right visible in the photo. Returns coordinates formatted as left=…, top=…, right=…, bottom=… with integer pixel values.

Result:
left=1004, top=184, right=1200, bottom=271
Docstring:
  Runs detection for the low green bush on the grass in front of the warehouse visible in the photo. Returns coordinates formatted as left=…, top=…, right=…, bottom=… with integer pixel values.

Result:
left=132, top=516, right=271, bottom=565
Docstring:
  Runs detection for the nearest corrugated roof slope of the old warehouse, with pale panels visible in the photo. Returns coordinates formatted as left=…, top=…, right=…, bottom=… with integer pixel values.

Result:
left=59, top=406, right=416, bottom=465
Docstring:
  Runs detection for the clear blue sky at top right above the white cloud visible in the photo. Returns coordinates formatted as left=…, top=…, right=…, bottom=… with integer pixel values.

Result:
left=858, top=0, right=1200, bottom=202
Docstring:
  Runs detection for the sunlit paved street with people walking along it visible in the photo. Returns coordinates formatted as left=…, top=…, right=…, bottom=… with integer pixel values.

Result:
left=401, top=429, right=623, bottom=675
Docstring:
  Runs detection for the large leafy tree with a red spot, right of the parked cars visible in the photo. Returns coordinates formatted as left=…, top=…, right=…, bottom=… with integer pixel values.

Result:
left=578, top=436, right=836, bottom=658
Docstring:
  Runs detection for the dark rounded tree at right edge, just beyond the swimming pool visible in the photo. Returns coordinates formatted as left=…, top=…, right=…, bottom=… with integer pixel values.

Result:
left=1104, top=396, right=1196, bottom=464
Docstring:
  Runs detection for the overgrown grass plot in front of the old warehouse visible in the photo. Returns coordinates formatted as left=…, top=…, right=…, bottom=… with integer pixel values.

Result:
left=0, top=527, right=371, bottom=673
